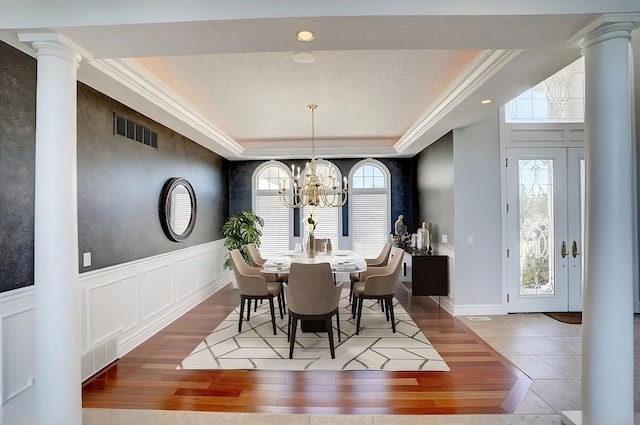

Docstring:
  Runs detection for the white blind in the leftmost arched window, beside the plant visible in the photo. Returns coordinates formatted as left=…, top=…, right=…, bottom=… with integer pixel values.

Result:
left=254, top=193, right=291, bottom=257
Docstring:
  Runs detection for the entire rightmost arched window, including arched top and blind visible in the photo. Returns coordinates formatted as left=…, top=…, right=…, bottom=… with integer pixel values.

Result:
left=349, top=159, right=391, bottom=258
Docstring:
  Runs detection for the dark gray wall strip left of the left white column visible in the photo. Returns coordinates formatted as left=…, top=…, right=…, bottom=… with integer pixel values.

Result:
left=0, top=43, right=36, bottom=292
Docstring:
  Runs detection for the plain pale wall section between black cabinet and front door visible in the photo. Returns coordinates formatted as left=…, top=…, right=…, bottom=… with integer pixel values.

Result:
left=452, top=111, right=505, bottom=315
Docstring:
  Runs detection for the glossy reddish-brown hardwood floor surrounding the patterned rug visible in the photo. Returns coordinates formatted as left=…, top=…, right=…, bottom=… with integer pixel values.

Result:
left=83, top=285, right=531, bottom=415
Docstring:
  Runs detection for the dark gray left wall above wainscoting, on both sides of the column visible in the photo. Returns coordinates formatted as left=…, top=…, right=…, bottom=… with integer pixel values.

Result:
left=0, top=42, right=229, bottom=292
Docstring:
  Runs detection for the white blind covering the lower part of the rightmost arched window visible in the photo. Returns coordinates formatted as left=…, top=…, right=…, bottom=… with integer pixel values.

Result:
left=349, top=191, right=390, bottom=258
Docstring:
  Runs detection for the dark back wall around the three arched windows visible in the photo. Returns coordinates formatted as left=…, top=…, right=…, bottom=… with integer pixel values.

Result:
left=229, top=158, right=414, bottom=236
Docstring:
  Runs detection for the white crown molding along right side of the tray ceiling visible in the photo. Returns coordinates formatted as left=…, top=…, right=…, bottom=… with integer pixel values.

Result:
left=394, top=49, right=522, bottom=154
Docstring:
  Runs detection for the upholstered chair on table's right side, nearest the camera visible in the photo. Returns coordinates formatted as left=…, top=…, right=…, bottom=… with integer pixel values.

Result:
left=351, top=250, right=404, bottom=335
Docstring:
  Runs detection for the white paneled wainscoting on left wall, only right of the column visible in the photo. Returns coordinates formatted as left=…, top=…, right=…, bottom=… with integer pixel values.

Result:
left=80, top=240, right=231, bottom=379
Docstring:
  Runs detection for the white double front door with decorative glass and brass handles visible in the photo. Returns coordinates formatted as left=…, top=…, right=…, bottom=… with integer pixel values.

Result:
left=507, top=148, right=584, bottom=312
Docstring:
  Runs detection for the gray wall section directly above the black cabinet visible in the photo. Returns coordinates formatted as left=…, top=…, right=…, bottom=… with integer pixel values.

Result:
left=414, top=132, right=455, bottom=245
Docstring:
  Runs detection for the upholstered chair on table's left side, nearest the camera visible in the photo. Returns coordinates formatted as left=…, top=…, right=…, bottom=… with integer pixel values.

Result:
left=229, top=249, right=284, bottom=335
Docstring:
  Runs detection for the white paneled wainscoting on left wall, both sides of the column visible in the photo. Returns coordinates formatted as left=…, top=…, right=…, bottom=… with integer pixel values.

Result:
left=0, top=240, right=231, bottom=425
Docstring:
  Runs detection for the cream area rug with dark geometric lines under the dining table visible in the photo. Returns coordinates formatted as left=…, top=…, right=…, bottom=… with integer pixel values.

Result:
left=178, top=288, right=449, bottom=371
